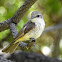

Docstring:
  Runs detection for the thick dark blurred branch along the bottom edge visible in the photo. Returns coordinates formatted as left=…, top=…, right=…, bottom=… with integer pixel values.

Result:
left=8, top=51, right=62, bottom=62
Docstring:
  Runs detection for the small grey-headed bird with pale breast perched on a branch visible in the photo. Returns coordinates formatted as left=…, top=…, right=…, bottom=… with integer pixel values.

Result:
left=2, top=11, right=45, bottom=54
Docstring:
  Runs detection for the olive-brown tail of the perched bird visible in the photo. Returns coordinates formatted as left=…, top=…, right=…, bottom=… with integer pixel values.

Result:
left=2, top=42, right=20, bottom=54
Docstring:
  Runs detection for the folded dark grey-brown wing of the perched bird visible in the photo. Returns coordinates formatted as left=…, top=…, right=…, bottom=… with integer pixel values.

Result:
left=14, top=21, right=35, bottom=41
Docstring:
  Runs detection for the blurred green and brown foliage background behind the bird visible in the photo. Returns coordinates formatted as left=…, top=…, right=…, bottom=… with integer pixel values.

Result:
left=0, top=0, right=62, bottom=59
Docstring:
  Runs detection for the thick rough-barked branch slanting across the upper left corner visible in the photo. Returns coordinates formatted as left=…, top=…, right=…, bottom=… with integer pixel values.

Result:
left=0, top=0, right=37, bottom=32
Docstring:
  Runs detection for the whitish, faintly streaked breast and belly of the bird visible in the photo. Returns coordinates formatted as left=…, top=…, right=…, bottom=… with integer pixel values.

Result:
left=27, top=18, right=45, bottom=39
